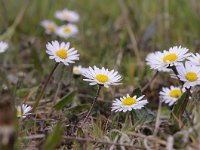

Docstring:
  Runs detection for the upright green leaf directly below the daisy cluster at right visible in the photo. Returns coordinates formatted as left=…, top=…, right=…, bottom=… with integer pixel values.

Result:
left=170, top=90, right=190, bottom=124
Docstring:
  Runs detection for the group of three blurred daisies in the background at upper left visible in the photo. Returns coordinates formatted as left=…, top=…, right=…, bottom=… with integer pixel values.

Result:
left=41, top=9, right=79, bottom=39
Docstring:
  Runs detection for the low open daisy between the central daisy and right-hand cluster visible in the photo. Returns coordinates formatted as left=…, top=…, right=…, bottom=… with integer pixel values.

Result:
left=112, top=94, right=148, bottom=112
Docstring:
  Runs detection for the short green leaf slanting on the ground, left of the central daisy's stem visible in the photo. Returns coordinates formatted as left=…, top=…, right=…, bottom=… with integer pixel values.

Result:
left=54, top=91, right=76, bottom=111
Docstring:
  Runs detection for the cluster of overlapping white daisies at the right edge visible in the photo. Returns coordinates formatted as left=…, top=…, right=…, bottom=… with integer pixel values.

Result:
left=146, top=46, right=200, bottom=106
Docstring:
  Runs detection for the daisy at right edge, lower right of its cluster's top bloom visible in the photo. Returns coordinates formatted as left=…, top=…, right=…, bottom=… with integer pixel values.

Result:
left=177, top=61, right=200, bottom=88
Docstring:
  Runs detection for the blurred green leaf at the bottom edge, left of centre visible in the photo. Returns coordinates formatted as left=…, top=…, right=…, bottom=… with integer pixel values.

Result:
left=44, top=123, right=64, bottom=150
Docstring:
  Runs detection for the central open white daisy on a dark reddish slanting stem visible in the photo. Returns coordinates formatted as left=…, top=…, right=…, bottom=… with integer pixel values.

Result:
left=83, top=66, right=122, bottom=88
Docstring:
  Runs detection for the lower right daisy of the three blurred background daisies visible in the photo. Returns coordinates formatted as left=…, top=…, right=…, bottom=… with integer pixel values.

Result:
left=56, top=24, right=78, bottom=39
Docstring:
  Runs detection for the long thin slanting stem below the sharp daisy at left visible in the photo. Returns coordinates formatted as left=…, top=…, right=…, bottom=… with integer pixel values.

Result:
left=32, top=63, right=59, bottom=112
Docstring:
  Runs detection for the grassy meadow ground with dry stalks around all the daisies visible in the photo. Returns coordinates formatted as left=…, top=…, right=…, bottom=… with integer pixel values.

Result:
left=0, top=0, right=200, bottom=150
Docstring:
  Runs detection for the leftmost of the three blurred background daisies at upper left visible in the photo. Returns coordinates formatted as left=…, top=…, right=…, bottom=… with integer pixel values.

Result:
left=41, top=20, right=57, bottom=34
